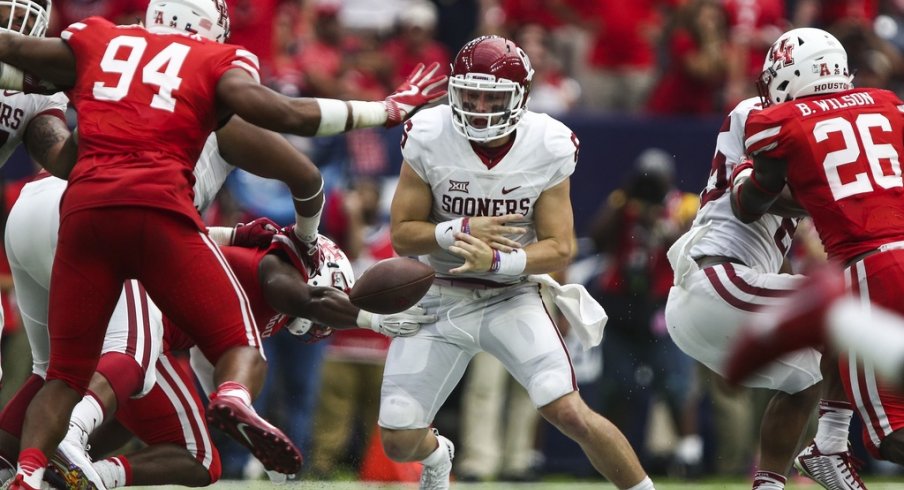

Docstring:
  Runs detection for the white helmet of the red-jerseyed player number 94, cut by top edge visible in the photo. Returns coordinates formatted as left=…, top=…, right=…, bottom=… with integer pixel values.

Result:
left=144, top=0, right=229, bottom=43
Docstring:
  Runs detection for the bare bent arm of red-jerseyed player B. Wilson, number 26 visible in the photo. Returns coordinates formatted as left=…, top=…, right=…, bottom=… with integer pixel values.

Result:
left=731, top=155, right=788, bottom=223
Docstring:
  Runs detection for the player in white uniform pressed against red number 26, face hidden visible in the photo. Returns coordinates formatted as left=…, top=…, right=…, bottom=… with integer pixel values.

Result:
left=665, top=98, right=861, bottom=489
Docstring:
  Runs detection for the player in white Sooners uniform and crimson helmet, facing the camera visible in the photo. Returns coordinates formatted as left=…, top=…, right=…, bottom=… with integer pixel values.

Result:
left=379, top=36, right=653, bottom=490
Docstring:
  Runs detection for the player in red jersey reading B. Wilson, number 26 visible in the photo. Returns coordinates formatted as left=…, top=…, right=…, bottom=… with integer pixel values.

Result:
left=731, top=28, right=904, bottom=470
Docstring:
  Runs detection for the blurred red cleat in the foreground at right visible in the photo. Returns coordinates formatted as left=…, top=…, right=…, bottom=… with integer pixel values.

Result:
left=725, top=266, right=845, bottom=384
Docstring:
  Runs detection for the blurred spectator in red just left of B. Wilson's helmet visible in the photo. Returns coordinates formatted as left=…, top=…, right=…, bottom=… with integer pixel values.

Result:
left=647, top=0, right=730, bottom=114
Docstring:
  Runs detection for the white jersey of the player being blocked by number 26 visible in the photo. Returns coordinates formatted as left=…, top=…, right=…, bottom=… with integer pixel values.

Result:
left=688, top=97, right=798, bottom=273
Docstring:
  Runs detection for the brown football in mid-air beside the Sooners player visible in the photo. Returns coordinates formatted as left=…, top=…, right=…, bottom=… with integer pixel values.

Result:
left=348, top=257, right=435, bottom=315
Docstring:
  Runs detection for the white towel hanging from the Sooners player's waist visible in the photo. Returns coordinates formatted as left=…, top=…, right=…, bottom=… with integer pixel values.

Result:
left=527, top=274, right=609, bottom=350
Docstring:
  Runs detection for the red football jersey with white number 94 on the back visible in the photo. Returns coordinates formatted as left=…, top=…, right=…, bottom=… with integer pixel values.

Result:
left=61, top=17, right=259, bottom=229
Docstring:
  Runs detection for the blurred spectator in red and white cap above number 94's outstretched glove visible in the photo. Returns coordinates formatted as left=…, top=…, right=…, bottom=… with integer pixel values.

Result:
left=383, top=0, right=451, bottom=87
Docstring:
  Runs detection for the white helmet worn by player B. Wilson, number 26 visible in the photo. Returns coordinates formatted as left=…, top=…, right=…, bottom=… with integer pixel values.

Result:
left=757, top=27, right=854, bottom=106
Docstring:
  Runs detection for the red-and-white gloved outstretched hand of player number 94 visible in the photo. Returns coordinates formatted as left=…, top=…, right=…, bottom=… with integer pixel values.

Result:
left=383, top=62, right=449, bottom=128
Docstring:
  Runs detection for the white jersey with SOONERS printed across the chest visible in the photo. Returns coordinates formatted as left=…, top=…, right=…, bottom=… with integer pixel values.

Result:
left=402, top=105, right=579, bottom=279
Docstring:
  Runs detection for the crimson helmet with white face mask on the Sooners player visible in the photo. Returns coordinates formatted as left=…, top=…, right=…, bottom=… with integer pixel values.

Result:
left=449, top=36, right=534, bottom=142
